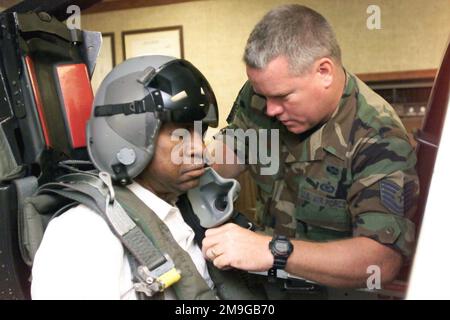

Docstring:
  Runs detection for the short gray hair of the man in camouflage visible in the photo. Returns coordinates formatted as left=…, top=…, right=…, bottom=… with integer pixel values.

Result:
left=244, top=4, right=342, bottom=74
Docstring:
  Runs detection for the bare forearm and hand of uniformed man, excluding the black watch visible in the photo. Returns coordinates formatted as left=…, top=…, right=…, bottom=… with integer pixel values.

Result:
left=202, top=223, right=402, bottom=288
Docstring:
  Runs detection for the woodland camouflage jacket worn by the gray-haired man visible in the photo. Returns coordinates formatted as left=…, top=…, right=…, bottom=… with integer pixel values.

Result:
left=221, top=73, right=419, bottom=257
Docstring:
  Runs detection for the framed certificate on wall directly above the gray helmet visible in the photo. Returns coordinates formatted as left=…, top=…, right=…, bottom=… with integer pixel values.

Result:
left=122, top=26, right=184, bottom=59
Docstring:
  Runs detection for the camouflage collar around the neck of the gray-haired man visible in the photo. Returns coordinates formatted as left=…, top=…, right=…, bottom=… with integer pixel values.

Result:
left=281, top=69, right=357, bottom=163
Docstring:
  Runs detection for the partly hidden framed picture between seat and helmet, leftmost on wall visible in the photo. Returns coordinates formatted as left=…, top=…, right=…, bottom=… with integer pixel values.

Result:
left=91, top=33, right=116, bottom=94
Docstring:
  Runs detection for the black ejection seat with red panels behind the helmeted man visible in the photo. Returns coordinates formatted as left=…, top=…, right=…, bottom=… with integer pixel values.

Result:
left=0, top=12, right=97, bottom=299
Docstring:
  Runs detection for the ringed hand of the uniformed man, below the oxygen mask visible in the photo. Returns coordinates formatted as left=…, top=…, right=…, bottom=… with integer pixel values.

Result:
left=202, top=223, right=273, bottom=271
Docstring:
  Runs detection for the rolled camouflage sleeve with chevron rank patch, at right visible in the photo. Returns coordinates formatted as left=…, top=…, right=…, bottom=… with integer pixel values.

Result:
left=348, top=136, right=419, bottom=258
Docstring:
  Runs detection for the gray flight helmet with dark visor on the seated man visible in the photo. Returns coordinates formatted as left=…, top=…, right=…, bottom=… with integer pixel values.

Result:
left=86, top=55, right=218, bottom=184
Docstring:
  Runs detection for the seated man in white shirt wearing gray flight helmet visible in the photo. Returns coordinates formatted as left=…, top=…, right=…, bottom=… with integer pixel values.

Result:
left=32, top=56, right=221, bottom=299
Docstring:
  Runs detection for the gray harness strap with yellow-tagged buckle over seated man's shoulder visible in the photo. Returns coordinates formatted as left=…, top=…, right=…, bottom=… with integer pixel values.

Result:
left=39, top=173, right=180, bottom=296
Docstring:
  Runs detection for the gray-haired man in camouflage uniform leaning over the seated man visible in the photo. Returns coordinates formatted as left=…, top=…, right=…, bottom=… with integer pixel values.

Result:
left=202, top=5, right=418, bottom=288
